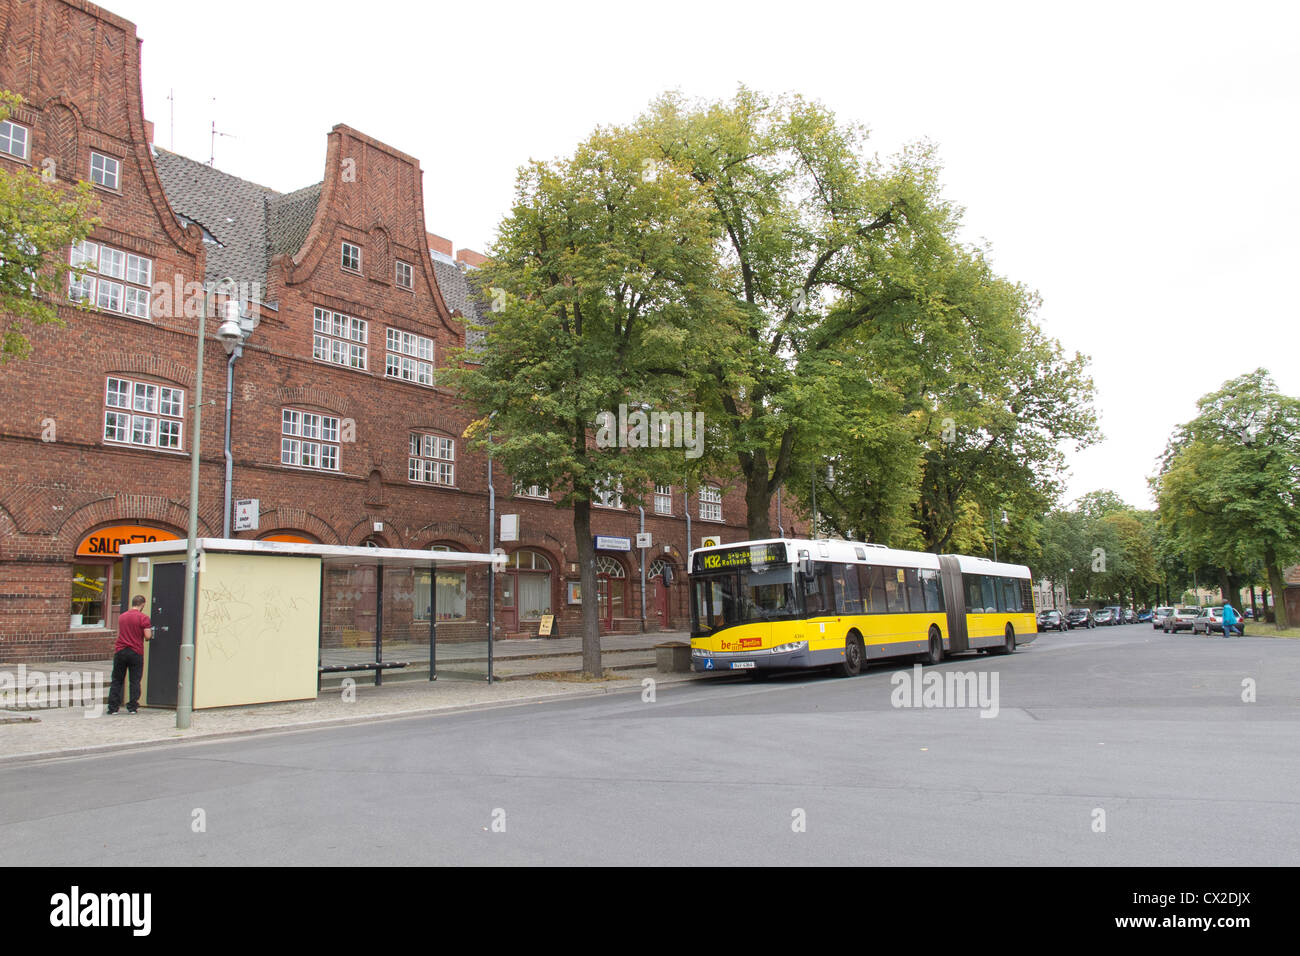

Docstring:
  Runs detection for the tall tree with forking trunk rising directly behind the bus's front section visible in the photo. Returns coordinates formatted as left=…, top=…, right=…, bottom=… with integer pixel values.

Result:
left=641, top=87, right=949, bottom=537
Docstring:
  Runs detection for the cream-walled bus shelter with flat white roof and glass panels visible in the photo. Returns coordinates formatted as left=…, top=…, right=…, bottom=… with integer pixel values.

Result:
left=121, top=538, right=502, bottom=710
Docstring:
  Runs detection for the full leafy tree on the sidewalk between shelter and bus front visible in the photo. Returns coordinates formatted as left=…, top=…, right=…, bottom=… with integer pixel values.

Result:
left=455, top=121, right=725, bottom=675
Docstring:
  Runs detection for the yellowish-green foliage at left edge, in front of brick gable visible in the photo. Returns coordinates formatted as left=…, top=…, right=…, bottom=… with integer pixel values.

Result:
left=0, top=91, right=99, bottom=364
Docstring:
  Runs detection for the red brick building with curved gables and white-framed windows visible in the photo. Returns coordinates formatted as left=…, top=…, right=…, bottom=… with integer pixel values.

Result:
left=0, top=0, right=794, bottom=661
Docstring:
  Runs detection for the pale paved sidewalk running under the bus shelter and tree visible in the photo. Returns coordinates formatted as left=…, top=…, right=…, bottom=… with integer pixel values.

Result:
left=0, top=635, right=705, bottom=765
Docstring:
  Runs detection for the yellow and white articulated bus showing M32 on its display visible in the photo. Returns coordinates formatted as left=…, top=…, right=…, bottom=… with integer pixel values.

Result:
left=690, top=538, right=1037, bottom=676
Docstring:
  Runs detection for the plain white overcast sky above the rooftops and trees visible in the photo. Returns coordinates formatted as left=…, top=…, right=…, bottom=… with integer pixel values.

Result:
left=107, top=0, right=1300, bottom=507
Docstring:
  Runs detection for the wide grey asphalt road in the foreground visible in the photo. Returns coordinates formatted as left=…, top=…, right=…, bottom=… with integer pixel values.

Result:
left=0, top=624, right=1300, bottom=866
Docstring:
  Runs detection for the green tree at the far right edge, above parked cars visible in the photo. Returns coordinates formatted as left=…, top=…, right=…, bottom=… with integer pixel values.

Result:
left=1154, top=368, right=1300, bottom=627
